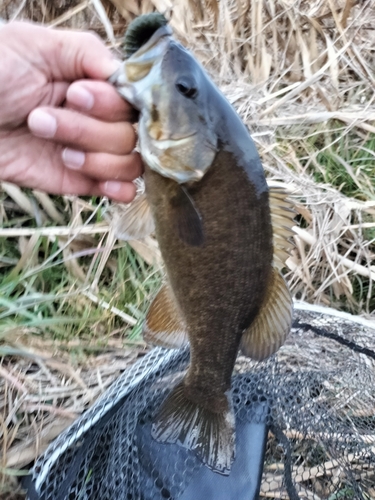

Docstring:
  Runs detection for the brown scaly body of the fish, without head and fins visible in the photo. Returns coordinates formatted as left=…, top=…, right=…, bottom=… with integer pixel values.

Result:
left=145, top=151, right=272, bottom=406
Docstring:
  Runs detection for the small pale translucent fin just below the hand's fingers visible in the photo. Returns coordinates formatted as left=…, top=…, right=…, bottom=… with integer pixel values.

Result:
left=108, top=178, right=155, bottom=241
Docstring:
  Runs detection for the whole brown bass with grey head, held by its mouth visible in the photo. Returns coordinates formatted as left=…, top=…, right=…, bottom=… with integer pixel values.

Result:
left=110, top=13, right=295, bottom=475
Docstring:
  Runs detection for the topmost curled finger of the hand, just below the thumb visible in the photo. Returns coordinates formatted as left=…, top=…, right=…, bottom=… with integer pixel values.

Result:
left=66, top=80, right=135, bottom=122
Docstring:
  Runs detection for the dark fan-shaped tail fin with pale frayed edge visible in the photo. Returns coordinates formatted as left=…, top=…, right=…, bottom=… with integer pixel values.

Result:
left=152, top=383, right=235, bottom=475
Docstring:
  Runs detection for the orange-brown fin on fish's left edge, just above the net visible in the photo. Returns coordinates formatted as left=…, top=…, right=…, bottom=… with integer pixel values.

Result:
left=143, top=285, right=188, bottom=349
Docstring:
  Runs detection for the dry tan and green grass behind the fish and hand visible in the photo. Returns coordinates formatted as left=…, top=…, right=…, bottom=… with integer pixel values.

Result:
left=0, top=0, right=375, bottom=498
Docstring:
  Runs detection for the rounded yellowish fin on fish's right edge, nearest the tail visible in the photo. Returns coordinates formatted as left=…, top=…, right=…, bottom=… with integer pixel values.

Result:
left=240, top=269, right=293, bottom=361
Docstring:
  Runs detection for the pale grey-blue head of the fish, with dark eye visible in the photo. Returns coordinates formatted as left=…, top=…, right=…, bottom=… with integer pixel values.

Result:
left=111, top=20, right=218, bottom=184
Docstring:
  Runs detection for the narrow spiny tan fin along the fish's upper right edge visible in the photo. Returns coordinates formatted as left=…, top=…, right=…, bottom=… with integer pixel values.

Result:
left=268, top=181, right=296, bottom=270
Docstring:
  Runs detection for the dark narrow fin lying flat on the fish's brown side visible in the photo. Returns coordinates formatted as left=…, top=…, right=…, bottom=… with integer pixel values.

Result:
left=171, top=185, right=204, bottom=247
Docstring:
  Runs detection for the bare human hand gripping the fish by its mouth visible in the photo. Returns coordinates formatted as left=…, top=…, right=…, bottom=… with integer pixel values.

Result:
left=0, top=22, right=142, bottom=202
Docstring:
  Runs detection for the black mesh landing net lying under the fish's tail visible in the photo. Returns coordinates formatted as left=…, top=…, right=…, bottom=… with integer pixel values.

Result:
left=28, top=309, right=375, bottom=500
